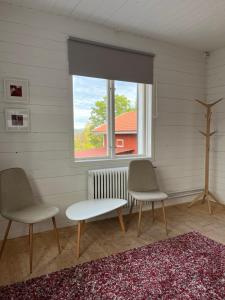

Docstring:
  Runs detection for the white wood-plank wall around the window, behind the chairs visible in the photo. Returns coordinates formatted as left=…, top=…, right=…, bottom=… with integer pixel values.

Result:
left=0, top=4, right=205, bottom=237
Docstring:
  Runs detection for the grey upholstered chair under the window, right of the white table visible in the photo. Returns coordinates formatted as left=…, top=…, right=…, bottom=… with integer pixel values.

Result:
left=128, top=159, right=168, bottom=236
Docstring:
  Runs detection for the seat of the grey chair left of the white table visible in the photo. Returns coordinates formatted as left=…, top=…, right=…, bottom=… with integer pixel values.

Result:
left=2, top=204, right=59, bottom=224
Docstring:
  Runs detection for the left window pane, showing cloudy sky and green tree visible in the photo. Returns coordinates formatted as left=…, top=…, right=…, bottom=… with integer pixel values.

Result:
left=73, top=75, right=108, bottom=159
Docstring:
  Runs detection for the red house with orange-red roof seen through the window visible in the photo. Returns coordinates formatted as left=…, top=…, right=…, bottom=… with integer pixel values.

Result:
left=76, top=111, right=137, bottom=158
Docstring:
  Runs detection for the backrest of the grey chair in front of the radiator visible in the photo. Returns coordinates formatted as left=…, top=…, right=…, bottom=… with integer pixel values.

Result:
left=128, top=159, right=158, bottom=192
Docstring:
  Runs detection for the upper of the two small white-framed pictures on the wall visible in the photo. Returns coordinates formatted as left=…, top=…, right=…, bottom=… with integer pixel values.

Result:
left=4, top=78, right=29, bottom=104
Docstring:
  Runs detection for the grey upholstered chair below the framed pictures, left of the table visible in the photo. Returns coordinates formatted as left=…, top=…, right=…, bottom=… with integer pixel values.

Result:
left=0, top=168, right=61, bottom=273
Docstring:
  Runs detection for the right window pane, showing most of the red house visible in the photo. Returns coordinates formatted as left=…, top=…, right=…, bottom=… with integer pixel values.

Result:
left=115, top=81, right=144, bottom=156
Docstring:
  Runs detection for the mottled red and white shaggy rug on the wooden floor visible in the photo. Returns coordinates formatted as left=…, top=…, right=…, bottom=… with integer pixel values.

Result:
left=0, top=232, right=225, bottom=300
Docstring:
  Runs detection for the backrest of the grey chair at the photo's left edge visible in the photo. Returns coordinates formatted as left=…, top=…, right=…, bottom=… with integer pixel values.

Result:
left=0, top=168, right=34, bottom=212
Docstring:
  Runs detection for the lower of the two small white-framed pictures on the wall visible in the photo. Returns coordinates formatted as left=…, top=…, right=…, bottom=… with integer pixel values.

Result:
left=5, top=108, right=30, bottom=132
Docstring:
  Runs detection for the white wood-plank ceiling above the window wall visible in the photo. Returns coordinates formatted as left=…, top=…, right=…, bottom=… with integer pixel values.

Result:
left=0, top=0, right=225, bottom=50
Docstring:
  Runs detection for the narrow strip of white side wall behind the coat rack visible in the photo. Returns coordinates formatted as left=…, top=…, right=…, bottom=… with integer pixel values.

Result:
left=207, top=48, right=225, bottom=203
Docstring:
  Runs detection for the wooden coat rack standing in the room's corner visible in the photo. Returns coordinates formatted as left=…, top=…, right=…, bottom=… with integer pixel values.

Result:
left=189, top=98, right=223, bottom=214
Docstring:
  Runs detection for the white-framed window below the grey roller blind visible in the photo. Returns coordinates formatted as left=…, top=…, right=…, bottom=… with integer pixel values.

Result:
left=72, top=75, right=152, bottom=160
